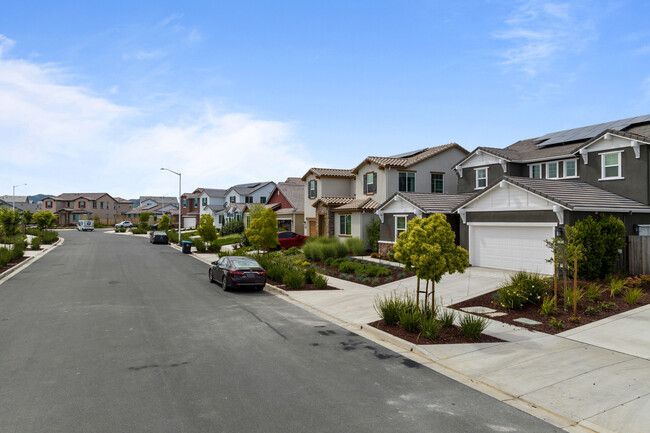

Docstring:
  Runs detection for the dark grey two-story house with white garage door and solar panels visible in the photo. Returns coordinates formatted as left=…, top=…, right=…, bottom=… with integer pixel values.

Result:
left=454, top=115, right=650, bottom=273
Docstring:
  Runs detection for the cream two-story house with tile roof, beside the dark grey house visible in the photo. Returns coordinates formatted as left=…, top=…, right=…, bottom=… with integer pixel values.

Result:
left=303, top=143, right=469, bottom=244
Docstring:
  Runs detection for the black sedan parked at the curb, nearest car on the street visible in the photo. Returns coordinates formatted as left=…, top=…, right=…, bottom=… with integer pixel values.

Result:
left=208, top=256, right=266, bottom=291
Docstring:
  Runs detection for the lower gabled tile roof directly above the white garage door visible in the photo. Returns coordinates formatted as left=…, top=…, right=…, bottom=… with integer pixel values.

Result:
left=455, top=176, right=650, bottom=213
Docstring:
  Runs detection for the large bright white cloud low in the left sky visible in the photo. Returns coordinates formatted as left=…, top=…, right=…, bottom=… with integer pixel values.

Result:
left=0, top=46, right=310, bottom=198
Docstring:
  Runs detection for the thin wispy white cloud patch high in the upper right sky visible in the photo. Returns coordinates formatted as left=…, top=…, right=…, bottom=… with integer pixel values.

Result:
left=493, top=0, right=593, bottom=76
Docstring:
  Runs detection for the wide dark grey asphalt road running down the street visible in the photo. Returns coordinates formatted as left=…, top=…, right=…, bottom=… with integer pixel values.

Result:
left=0, top=231, right=559, bottom=433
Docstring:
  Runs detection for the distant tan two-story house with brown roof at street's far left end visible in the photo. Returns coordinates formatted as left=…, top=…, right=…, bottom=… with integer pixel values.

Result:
left=41, top=192, right=124, bottom=225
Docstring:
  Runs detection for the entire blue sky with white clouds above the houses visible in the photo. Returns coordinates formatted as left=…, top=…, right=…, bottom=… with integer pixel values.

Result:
left=0, top=0, right=650, bottom=198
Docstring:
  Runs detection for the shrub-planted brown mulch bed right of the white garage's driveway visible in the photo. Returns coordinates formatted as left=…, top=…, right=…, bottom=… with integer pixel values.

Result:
left=450, top=289, right=650, bottom=334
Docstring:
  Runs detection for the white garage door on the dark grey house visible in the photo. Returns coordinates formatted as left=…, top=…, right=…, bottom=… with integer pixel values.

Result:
left=469, top=224, right=554, bottom=274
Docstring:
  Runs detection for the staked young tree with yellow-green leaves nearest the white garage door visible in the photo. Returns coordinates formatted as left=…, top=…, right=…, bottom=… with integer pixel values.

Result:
left=394, top=214, right=469, bottom=312
